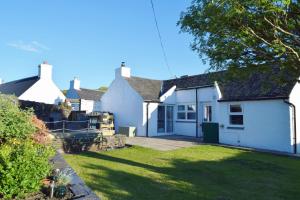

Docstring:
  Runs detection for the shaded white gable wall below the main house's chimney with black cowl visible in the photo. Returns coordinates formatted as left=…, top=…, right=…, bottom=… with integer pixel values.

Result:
left=101, top=76, right=146, bottom=136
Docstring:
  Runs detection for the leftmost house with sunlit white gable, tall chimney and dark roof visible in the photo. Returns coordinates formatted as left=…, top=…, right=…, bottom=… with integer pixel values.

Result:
left=0, top=62, right=65, bottom=104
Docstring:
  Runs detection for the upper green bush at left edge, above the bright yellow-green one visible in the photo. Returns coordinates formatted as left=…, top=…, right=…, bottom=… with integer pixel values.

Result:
left=0, top=94, right=35, bottom=144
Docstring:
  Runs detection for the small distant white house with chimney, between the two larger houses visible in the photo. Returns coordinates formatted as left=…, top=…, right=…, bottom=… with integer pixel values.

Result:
left=66, top=77, right=104, bottom=113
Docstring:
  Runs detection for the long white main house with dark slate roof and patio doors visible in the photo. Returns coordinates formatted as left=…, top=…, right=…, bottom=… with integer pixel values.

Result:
left=101, top=63, right=300, bottom=153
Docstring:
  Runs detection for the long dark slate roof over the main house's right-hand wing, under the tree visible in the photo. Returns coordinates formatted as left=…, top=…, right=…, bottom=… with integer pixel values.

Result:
left=162, top=71, right=297, bottom=101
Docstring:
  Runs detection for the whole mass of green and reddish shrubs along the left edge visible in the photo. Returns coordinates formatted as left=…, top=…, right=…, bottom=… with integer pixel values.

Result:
left=0, top=94, right=54, bottom=199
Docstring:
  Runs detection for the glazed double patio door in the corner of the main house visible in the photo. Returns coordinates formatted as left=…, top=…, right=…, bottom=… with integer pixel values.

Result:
left=157, top=105, right=174, bottom=135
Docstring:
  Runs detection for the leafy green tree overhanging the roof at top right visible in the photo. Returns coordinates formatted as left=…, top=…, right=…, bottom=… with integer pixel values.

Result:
left=178, top=0, right=300, bottom=78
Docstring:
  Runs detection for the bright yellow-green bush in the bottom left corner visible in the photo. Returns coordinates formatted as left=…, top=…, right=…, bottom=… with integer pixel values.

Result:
left=0, top=139, right=54, bottom=199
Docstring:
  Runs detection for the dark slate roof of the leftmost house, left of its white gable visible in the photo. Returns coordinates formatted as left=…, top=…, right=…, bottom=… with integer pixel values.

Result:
left=0, top=76, right=39, bottom=97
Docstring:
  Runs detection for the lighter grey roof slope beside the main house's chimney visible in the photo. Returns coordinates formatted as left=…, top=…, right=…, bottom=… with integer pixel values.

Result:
left=125, top=76, right=162, bottom=101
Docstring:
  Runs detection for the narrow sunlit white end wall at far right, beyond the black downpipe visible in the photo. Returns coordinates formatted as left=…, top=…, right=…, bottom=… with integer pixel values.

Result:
left=290, top=83, right=300, bottom=153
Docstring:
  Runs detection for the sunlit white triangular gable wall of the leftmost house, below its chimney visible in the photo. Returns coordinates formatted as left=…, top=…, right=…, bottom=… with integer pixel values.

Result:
left=19, top=78, right=65, bottom=104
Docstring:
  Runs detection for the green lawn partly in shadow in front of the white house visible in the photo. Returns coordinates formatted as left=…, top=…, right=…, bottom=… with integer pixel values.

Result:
left=64, top=145, right=300, bottom=200
